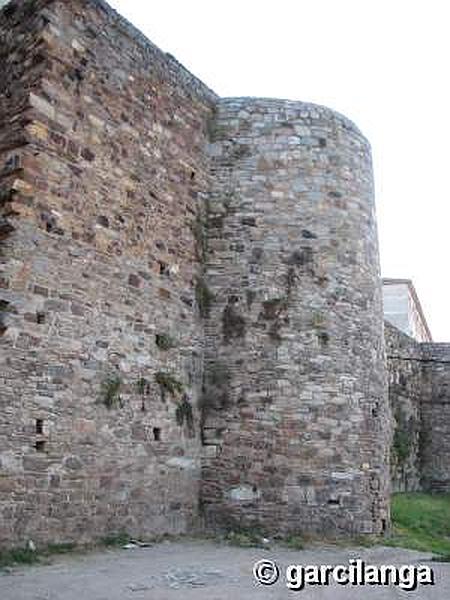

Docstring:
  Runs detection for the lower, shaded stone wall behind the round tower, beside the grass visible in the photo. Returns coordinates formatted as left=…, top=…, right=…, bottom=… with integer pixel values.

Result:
left=385, top=323, right=450, bottom=492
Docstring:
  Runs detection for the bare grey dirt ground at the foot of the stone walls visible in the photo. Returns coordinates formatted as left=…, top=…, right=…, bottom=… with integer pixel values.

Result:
left=0, top=541, right=450, bottom=600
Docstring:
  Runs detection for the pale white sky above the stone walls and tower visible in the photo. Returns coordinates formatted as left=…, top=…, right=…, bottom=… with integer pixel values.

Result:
left=110, top=0, right=450, bottom=342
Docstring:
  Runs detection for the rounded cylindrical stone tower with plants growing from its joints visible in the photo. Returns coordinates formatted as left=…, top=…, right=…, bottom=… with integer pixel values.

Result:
left=202, top=98, right=390, bottom=534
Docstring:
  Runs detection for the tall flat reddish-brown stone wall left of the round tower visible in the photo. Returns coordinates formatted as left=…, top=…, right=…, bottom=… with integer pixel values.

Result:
left=0, top=0, right=215, bottom=545
